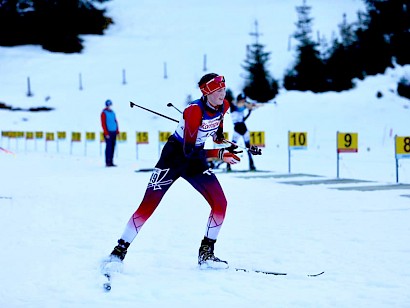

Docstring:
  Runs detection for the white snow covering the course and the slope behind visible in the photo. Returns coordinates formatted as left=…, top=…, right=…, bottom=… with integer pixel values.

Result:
left=0, top=0, right=410, bottom=307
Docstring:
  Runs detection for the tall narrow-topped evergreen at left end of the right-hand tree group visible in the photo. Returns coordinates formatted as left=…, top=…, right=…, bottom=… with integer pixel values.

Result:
left=284, top=0, right=327, bottom=92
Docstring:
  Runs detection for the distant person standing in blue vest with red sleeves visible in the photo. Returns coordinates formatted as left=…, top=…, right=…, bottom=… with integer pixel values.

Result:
left=101, top=99, right=120, bottom=167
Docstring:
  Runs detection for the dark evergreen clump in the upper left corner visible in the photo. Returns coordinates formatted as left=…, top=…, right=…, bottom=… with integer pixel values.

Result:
left=0, top=0, right=112, bottom=52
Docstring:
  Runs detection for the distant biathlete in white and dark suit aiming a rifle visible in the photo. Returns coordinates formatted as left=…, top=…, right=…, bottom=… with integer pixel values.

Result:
left=227, top=94, right=256, bottom=171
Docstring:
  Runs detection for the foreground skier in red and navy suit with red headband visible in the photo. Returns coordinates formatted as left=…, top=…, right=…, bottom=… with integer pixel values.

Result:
left=105, top=73, right=240, bottom=268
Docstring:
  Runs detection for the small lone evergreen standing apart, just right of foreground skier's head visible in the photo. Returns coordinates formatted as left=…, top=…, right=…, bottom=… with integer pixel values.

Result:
left=243, top=21, right=278, bottom=103
